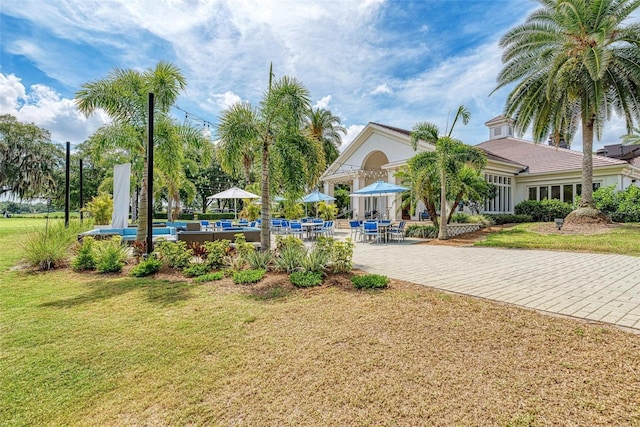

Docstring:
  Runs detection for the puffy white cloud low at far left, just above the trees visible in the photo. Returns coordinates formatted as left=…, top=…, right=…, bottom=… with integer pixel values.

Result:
left=0, top=73, right=108, bottom=144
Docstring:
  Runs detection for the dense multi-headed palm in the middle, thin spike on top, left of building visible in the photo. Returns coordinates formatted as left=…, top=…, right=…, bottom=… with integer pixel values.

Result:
left=218, top=70, right=324, bottom=250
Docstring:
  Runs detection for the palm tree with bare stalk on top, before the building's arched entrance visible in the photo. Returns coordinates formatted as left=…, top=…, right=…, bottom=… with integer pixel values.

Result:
left=410, top=105, right=487, bottom=240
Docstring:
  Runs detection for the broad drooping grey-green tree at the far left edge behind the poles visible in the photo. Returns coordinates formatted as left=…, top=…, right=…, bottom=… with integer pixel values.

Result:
left=0, top=114, right=64, bottom=199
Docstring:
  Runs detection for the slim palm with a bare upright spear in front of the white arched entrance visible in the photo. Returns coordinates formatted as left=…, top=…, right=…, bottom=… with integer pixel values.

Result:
left=411, top=105, right=486, bottom=240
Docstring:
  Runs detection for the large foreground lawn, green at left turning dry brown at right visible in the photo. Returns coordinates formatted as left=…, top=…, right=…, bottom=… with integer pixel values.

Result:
left=0, top=219, right=640, bottom=426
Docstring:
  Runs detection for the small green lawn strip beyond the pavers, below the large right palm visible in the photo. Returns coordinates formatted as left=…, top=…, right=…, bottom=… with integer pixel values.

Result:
left=475, top=224, right=640, bottom=256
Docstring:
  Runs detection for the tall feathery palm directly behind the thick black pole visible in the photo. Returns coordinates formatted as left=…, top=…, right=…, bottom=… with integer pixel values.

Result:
left=75, top=62, right=186, bottom=242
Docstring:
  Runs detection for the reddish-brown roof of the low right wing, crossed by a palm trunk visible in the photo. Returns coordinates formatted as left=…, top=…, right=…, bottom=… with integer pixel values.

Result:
left=477, top=137, right=627, bottom=174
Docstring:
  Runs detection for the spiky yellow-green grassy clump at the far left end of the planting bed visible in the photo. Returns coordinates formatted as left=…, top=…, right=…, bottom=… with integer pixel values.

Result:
left=21, top=222, right=80, bottom=270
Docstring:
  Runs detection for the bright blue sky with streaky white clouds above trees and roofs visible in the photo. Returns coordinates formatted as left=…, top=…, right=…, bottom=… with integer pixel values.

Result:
left=0, top=0, right=637, bottom=154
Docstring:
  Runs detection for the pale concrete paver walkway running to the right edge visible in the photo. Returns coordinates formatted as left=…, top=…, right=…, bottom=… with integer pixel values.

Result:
left=348, top=236, right=640, bottom=329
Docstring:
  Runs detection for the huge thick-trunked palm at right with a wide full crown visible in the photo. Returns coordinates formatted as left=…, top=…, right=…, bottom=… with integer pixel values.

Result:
left=495, top=0, right=640, bottom=223
